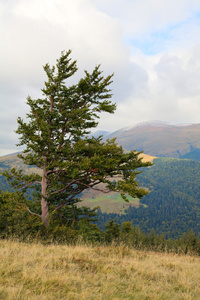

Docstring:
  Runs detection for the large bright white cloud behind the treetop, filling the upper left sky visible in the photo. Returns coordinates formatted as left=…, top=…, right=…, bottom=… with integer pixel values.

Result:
left=0, top=0, right=130, bottom=155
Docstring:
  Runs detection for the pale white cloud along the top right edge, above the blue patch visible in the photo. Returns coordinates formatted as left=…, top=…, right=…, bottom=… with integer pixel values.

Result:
left=95, top=0, right=200, bottom=35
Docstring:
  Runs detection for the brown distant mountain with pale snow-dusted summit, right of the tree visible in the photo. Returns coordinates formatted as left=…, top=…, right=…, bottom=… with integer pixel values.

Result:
left=107, top=121, right=200, bottom=160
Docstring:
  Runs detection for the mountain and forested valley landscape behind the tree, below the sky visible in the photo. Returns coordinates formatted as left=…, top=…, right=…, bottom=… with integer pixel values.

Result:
left=0, top=123, right=200, bottom=238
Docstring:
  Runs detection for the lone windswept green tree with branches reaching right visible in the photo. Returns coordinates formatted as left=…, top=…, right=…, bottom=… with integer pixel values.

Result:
left=4, top=51, right=150, bottom=226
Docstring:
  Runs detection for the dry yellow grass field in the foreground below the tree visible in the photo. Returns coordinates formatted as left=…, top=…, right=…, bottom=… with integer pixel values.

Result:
left=0, top=240, right=200, bottom=300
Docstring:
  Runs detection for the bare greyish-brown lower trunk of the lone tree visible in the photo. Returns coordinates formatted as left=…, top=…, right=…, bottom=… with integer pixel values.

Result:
left=41, top=168, right=49, bottom=226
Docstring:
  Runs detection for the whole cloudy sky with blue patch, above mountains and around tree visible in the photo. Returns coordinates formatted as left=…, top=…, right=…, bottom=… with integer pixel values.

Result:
left=0, top=0, right=200, bottom=156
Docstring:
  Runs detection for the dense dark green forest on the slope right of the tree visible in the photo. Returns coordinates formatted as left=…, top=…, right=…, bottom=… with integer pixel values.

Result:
left=97, top=158, right=200, bottom=238
